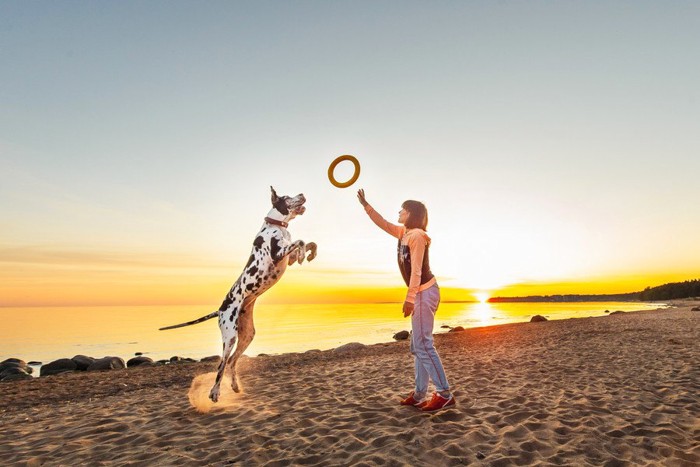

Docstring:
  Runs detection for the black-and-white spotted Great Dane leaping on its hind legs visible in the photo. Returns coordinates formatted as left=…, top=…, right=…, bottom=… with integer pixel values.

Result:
left=160, top=187, right=316, bottom=402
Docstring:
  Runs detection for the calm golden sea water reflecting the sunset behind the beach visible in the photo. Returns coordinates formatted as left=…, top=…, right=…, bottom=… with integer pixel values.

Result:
left=0, top=302, right=662, bottom=363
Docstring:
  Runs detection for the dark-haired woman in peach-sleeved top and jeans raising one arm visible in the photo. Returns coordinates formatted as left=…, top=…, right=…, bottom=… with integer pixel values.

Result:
left=357, top=190, right=455, bottom=412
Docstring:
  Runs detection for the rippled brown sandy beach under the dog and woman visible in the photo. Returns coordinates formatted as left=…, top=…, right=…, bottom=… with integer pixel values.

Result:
left=0, top=301, right=700, bottom=466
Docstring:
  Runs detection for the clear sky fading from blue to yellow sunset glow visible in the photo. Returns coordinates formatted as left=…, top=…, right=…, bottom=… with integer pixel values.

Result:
left=0, top=1, right=700, bottom=306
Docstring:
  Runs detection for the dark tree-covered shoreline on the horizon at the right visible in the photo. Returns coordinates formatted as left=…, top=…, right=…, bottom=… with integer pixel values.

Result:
left=489, top=279, right=700, bottom=303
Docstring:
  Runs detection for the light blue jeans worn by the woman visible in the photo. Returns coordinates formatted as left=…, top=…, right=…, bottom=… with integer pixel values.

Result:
left=411, top=284, right=450, bottom=400
